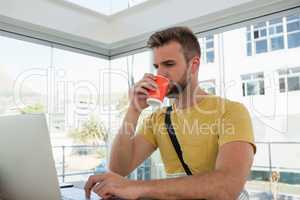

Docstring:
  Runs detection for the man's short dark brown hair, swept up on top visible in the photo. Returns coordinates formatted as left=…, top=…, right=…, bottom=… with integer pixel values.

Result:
left=147, top=26, right=201, bottom=62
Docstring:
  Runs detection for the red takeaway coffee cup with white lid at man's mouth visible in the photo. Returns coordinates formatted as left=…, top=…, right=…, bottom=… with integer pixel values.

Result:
left=147, top=75, right=169, bottom=107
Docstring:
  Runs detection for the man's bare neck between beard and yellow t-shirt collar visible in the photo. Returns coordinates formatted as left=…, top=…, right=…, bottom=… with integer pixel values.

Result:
left=175, top=81, right=207, bottom=109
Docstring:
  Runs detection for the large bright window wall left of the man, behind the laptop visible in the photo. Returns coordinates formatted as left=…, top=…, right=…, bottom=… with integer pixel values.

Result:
left=0, top=32, right=109, bottom=182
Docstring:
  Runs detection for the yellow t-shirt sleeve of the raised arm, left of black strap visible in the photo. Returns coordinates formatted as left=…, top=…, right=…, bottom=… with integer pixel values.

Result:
left=137, top=114, right=157, bottom=148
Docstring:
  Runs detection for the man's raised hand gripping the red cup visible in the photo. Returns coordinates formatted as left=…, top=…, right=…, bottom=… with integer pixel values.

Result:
left=129, top=73, right=158, bottom=112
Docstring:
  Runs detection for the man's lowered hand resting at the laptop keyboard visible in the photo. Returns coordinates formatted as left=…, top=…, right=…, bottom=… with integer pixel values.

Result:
left=84, top=172, right=140, bottom=199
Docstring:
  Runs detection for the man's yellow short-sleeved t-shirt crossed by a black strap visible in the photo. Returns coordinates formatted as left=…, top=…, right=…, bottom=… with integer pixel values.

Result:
left=138, top=95, right=256, bottom=174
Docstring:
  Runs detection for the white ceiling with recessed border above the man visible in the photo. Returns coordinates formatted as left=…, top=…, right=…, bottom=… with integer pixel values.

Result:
left=0, top=0, right=300, bottom=55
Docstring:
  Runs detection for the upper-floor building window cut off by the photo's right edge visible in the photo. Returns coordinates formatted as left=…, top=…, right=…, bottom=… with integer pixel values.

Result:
left=286, top=14, right=300, bottom=48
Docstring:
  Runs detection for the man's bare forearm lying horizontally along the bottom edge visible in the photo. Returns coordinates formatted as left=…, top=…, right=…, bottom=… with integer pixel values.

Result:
left=139, top=171, right=241, bottom=200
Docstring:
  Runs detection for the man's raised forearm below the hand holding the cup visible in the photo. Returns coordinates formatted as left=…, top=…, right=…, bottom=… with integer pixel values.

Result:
left=109, top=107, right=140, bottom=176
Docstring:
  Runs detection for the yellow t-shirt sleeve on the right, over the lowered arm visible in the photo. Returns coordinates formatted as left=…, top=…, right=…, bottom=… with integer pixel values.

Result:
left=218, top=102, right=256, bottom=153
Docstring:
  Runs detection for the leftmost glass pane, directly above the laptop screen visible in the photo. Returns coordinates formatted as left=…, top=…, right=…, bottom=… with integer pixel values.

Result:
left=0, top=36, right=51, bottom=115
